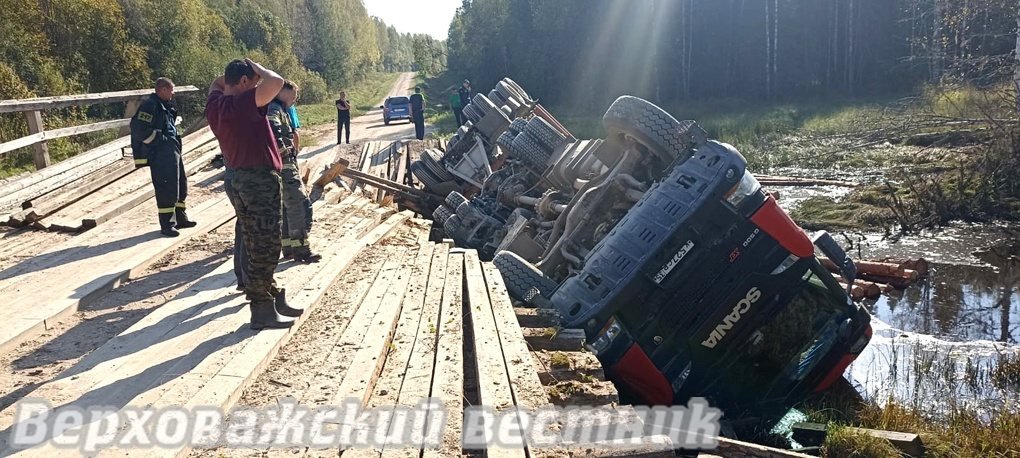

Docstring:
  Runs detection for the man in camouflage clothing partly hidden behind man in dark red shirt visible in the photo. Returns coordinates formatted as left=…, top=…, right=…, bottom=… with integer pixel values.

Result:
left=267, top=81, right=322, bottom=263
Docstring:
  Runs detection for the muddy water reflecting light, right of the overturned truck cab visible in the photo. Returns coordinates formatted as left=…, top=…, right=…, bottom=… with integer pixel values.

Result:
left=779, top=183, right=1020, bottom=415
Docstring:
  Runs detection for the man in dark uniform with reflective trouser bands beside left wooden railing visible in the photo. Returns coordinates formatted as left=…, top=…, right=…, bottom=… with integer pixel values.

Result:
left=131, top=77, right=197, bottom=237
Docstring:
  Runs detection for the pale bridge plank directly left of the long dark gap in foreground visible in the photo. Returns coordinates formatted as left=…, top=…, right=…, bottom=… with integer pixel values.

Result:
left=423, top=249, right=464, bottom=458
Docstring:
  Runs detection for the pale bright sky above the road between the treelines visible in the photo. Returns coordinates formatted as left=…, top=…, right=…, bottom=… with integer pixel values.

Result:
left=364, top=0, right=461, bottom=40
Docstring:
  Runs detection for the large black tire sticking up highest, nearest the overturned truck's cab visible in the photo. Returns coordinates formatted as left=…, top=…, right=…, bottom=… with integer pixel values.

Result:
left=602, top=96, right=689, bottom=164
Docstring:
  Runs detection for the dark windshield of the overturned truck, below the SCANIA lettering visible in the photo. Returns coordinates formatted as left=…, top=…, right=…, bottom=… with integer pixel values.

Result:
left=731, top=262, right=849, bottom=394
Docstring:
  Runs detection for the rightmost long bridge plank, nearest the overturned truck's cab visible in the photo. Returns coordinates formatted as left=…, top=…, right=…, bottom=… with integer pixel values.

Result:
left=481, top=262, right=549, bottom=409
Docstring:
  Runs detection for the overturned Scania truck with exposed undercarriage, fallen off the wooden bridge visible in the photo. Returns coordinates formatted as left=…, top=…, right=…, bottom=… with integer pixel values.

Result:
left=411, top=79, right=871, bottom=430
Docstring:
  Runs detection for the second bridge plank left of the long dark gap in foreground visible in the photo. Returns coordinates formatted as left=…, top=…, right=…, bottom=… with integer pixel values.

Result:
left=383, top=244, right=450, bottom=458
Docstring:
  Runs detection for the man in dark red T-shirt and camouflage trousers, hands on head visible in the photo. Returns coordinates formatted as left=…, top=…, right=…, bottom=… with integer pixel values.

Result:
left=205, top=59, right=303, bottom=329
